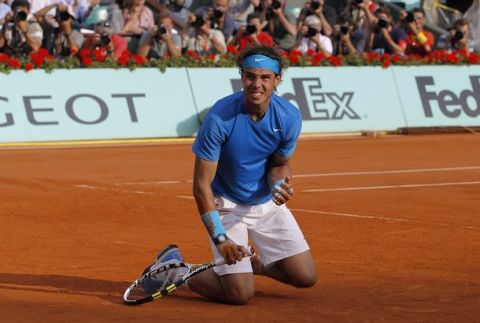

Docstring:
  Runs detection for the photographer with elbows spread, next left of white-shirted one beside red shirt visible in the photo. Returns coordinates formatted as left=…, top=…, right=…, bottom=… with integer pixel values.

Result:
left=137, top=12, right=182, bottom=58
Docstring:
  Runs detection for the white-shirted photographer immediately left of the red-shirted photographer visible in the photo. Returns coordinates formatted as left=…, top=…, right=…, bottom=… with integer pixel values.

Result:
left=185, top=11, right=227, bottom=57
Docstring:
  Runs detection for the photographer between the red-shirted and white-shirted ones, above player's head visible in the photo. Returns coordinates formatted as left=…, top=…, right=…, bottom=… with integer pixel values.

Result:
left=264, top=0, right=297, bottom=51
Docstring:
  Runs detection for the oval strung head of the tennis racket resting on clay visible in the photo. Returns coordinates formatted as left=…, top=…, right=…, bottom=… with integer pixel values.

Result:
left=123, top=261, right=190, bottom=305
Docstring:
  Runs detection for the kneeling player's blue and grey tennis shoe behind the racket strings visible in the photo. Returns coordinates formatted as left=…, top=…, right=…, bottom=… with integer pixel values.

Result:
left=143, top=245, right=188, bottom=294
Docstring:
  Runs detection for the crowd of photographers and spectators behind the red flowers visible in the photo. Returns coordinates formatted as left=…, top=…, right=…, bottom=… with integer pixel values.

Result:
left=0, top=0, right=473, bottom=60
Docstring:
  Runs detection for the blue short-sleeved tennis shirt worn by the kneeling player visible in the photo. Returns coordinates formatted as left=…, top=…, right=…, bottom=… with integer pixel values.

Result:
left=192, top=92, right=302, bottom=205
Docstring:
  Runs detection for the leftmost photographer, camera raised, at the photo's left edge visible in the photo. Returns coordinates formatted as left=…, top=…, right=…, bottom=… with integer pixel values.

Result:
left=0, top=0, right=43, bottom=56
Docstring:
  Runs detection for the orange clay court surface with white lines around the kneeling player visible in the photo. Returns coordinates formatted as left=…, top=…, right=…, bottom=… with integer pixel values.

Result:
left=0, top=134, right=480, bottom=322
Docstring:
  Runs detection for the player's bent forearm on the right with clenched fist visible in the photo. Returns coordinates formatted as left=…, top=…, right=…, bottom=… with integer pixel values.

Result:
left=268, top=153, right=293, bottom=205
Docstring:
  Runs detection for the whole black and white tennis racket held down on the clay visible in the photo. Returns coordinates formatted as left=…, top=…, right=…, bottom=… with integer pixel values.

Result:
left=123, top=248, right=254, bottom=305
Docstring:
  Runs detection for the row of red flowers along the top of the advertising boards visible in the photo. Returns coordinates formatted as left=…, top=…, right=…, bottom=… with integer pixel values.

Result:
left=0, top=46, right=480, bottom=73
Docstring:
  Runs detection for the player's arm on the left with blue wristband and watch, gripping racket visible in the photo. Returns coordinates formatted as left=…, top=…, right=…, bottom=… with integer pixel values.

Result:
left=193, top=156, right=249, bottom=265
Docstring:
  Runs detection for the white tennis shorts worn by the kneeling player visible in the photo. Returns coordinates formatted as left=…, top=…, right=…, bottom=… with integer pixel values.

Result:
left=210, top=197, right=310, bottom=276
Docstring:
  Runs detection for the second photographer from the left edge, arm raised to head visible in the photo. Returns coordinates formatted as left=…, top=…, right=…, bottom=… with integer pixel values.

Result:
left=35, top=3, right=83, bottom=59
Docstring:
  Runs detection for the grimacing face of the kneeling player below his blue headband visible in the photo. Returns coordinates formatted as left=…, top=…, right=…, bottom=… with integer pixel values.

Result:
left=242, top=68, right=280, bottom=110
